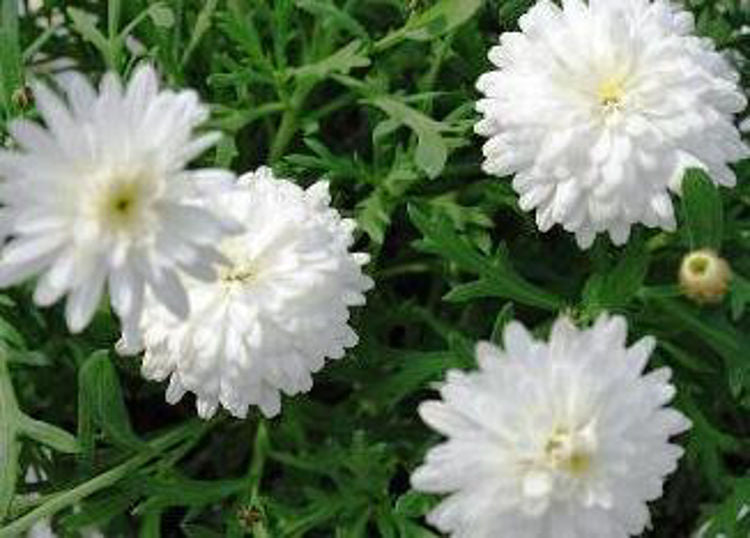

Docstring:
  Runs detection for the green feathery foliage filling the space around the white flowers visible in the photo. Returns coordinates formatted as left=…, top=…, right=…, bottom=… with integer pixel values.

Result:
left=0, top=0, right=750, bottom=538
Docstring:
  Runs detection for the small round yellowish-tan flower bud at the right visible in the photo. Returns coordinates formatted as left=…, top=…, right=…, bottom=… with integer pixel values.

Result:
left=680, top=249, right=732, bottom=304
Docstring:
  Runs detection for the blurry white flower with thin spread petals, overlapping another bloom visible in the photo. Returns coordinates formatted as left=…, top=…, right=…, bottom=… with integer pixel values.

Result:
left=0, top=65, right=236, bottom=345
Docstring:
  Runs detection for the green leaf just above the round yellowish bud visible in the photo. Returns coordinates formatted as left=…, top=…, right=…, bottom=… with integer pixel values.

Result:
left=682, top=168, right=724, bottom=251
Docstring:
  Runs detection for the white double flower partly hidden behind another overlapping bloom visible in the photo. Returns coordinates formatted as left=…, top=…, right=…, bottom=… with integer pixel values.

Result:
left=136, top=168, right=372, bottom=418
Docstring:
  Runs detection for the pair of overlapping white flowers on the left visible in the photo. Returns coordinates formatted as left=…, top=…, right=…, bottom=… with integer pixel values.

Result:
left=0, top=64, right=372, bottom=417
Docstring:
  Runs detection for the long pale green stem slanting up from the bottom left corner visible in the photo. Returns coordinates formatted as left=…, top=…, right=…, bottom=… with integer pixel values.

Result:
left=0, top=422, right=201, bottom=538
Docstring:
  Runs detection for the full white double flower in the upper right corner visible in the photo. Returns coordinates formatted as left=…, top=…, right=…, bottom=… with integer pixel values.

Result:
left=476, top=0, right=750, bottom=248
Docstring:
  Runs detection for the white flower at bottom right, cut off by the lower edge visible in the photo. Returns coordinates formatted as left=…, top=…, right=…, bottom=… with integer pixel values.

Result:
left=412, top=315, right=690, bottom=538
